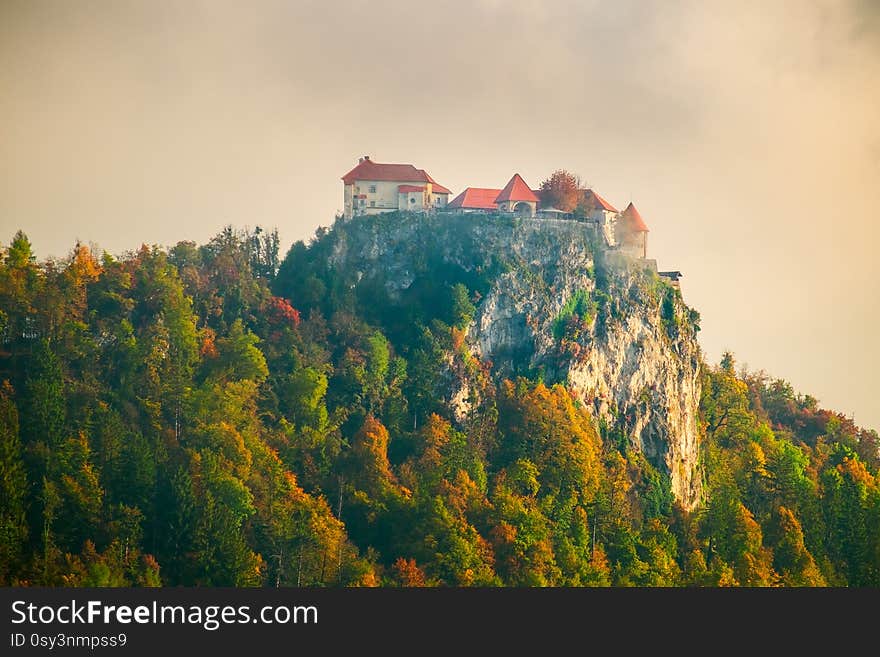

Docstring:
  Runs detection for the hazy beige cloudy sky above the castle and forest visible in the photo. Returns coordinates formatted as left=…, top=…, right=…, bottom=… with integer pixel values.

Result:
left=0, top=0, right=880, bottom=429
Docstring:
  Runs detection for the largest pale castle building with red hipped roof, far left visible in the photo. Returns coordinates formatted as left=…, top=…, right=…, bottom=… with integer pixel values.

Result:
left=342, top=155, right=451, bottom=219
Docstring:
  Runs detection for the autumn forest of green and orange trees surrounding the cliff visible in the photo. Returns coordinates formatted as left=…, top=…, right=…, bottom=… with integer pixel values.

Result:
left=0, top=227, right=880, bottom=587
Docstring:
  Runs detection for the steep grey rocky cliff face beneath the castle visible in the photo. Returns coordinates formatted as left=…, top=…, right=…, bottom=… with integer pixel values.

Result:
left=329, top=213, right=701, bottom=508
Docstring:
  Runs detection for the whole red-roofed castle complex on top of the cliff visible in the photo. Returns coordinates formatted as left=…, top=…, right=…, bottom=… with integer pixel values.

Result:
left=342, top=155, right=681, bottom=288
